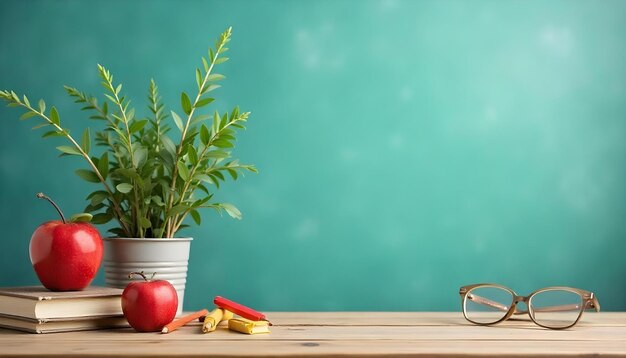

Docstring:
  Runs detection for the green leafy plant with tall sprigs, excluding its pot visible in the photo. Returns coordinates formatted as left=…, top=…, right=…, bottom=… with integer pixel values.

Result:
left=0, top=28, right=257, bottom=237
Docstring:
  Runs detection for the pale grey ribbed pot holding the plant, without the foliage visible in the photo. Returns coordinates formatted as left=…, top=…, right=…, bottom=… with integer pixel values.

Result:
left=103, top=238, right=193, bottom=316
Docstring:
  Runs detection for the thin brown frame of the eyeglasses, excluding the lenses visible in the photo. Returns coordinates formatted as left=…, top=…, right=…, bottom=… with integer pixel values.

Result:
left=459, top=283, right=600, bottom=330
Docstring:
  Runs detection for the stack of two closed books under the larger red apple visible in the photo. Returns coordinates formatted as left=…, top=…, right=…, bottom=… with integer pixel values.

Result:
left=0, top=286, right=128, bottom=333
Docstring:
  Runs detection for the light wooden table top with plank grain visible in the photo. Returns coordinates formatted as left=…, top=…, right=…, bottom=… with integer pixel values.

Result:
left=0, top=312, right=626, bottom=357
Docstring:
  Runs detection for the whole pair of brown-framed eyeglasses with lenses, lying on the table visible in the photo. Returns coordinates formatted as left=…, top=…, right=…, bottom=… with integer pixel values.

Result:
left=459, top=283, right=600, bottom=329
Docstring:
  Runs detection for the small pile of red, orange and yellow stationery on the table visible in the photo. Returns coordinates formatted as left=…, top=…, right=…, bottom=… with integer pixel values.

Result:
left=161, top=296, right=272, bottom=334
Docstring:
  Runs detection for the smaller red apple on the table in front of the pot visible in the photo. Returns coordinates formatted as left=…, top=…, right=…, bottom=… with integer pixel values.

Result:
left=122, top=271, right=178, bottom=332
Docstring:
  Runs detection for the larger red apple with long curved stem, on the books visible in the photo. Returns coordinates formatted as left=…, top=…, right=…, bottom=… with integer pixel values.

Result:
left=29, top=193, right=103, bottom=291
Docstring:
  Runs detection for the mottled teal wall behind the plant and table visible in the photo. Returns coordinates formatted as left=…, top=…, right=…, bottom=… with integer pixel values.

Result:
left=0, top=1, right=626, bottom=310
